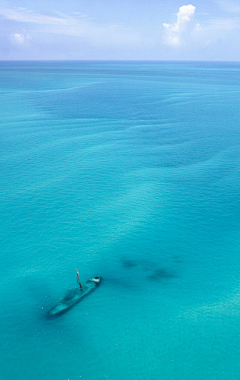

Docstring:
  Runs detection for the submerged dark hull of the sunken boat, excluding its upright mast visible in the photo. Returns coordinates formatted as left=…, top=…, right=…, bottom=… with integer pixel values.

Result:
left=47, top=276, right=101, bottom=317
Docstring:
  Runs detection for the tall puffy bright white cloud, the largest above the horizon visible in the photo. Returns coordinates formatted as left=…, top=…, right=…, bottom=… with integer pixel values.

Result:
left=163, top=4, right=197, bottom=47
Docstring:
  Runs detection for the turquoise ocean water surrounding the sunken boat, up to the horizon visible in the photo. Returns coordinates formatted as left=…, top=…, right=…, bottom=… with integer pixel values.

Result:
left=0, top=62, right=240, bottom=380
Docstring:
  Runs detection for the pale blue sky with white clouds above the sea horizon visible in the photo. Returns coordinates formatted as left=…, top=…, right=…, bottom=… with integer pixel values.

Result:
left=0, top=0, right=240, bottom=61
